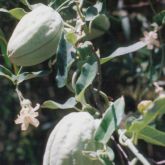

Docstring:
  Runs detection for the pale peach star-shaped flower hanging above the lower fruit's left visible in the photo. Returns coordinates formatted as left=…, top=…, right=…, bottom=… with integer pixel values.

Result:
left=15, top=99, right=40, bottom=131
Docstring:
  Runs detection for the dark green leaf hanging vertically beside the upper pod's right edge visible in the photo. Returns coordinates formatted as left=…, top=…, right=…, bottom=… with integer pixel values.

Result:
left=55, top=33, right=75, bottom=88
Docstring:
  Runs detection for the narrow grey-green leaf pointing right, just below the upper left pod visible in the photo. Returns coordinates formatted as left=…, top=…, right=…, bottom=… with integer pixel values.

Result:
left=12, top=71, right=50, bottom=85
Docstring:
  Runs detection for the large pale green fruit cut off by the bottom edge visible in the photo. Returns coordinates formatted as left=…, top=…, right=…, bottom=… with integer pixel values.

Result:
left=43, top=112, right=102, bottom=165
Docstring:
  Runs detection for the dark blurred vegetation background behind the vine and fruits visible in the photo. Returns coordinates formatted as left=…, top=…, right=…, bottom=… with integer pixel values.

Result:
left=0, top=0, right=165, bottom=165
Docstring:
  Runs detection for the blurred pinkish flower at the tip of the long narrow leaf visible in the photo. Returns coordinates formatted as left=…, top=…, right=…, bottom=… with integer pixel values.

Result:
left=142, top=31, right=160, bottom=49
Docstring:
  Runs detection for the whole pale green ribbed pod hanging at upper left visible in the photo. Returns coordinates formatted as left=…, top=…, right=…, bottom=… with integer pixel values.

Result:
left=7, top=5, right=63, bottom=66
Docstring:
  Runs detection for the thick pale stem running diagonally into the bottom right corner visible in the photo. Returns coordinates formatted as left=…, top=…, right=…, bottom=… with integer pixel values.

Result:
left=118, top=129, right=151, bottom=165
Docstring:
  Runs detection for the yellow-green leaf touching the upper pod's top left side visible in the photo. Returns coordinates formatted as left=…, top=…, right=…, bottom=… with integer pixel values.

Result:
left=0, top=8, right=27, bottom=20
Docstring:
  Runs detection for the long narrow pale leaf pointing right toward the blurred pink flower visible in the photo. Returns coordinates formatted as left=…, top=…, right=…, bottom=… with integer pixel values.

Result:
left=100, top=41, right=146, bottom=64
